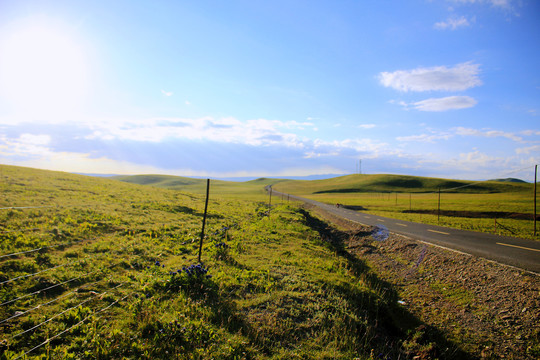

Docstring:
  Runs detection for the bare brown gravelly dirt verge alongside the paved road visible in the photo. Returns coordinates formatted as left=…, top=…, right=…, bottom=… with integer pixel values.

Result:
left=310, top=204, right=540, bottom=359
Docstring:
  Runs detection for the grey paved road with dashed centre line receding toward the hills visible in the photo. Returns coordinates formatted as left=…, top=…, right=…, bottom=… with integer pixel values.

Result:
left=272, top=190, right=540, bottom=273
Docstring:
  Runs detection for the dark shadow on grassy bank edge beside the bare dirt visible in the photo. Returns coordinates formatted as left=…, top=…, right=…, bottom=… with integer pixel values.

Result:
left=300, top=209, right=475, bottom=359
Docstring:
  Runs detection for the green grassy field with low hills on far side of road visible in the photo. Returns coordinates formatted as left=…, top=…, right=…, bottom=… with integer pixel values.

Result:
left=274, top=175, right=538, bottom=239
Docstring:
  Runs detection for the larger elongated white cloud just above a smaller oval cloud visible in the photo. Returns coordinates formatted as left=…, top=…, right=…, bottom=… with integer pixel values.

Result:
left=379, top=62, right=482, bottom=92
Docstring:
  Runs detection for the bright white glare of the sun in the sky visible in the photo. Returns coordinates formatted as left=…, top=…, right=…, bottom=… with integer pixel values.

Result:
left=0, top=20, right=89, bottom=121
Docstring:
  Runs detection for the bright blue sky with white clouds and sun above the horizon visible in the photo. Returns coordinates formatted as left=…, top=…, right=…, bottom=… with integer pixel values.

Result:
left=0, top=0, right=540, bottom=181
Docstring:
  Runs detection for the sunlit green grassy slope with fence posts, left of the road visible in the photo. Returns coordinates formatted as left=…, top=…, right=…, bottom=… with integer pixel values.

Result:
left=0, top=166, right=467, bottom=359
